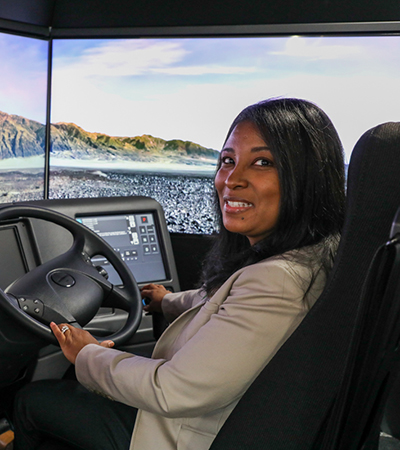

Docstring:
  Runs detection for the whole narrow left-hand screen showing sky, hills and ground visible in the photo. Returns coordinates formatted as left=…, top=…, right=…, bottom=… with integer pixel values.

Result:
left=0, top=33, right=47, bottom=203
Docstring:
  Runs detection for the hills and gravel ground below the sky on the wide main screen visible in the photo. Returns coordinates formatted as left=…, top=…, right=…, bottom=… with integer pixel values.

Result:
left=50, top=119, right=219, bottom=234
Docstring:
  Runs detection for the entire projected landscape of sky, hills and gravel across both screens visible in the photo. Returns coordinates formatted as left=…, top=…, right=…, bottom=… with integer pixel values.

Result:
left=0, top=35, right=400, bottom=233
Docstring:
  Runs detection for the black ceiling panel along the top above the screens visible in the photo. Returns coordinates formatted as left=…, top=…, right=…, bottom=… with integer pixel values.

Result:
left=0, top=0, right=400, bottom=36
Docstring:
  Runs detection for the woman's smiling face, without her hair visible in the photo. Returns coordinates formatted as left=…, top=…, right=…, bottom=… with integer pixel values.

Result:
left=215, top=122, right=281, bottom=245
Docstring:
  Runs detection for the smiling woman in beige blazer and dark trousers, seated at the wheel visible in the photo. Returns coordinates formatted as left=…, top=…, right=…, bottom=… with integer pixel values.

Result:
left=16, top=99, right=344, bottom=450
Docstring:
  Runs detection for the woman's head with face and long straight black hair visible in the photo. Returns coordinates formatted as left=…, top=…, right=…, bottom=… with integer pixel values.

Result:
left=203, top=98, right=345, bottom=294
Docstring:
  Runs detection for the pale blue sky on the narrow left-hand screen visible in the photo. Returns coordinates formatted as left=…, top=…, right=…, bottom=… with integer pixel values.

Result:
left=0, top=33, right=48, bottom=123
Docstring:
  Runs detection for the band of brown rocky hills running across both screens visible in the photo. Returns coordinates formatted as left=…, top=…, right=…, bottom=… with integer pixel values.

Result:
left=0, top=112, right=219, bottom=164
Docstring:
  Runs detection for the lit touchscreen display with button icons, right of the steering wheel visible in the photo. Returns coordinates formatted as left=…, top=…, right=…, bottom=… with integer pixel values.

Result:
left=76, top=212, right=167, bottom=284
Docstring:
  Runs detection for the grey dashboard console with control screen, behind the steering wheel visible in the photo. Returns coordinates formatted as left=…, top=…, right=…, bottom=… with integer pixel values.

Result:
left=0, top=197, right=179, bottom=290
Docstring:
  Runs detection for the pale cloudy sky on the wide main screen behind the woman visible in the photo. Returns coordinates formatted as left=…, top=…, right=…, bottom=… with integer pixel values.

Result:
left=52, top=36, right=400, bottom=162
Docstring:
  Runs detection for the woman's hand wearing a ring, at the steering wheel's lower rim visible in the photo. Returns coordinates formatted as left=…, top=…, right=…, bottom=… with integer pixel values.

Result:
left=50, top=322, right=114, bottom=364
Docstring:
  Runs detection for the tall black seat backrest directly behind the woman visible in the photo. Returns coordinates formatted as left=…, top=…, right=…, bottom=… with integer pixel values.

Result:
left=211, top=122, right=400, bottom=450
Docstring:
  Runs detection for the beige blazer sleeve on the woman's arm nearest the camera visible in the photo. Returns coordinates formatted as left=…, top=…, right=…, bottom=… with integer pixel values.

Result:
left=76, top=261, right=322, bottom=417
